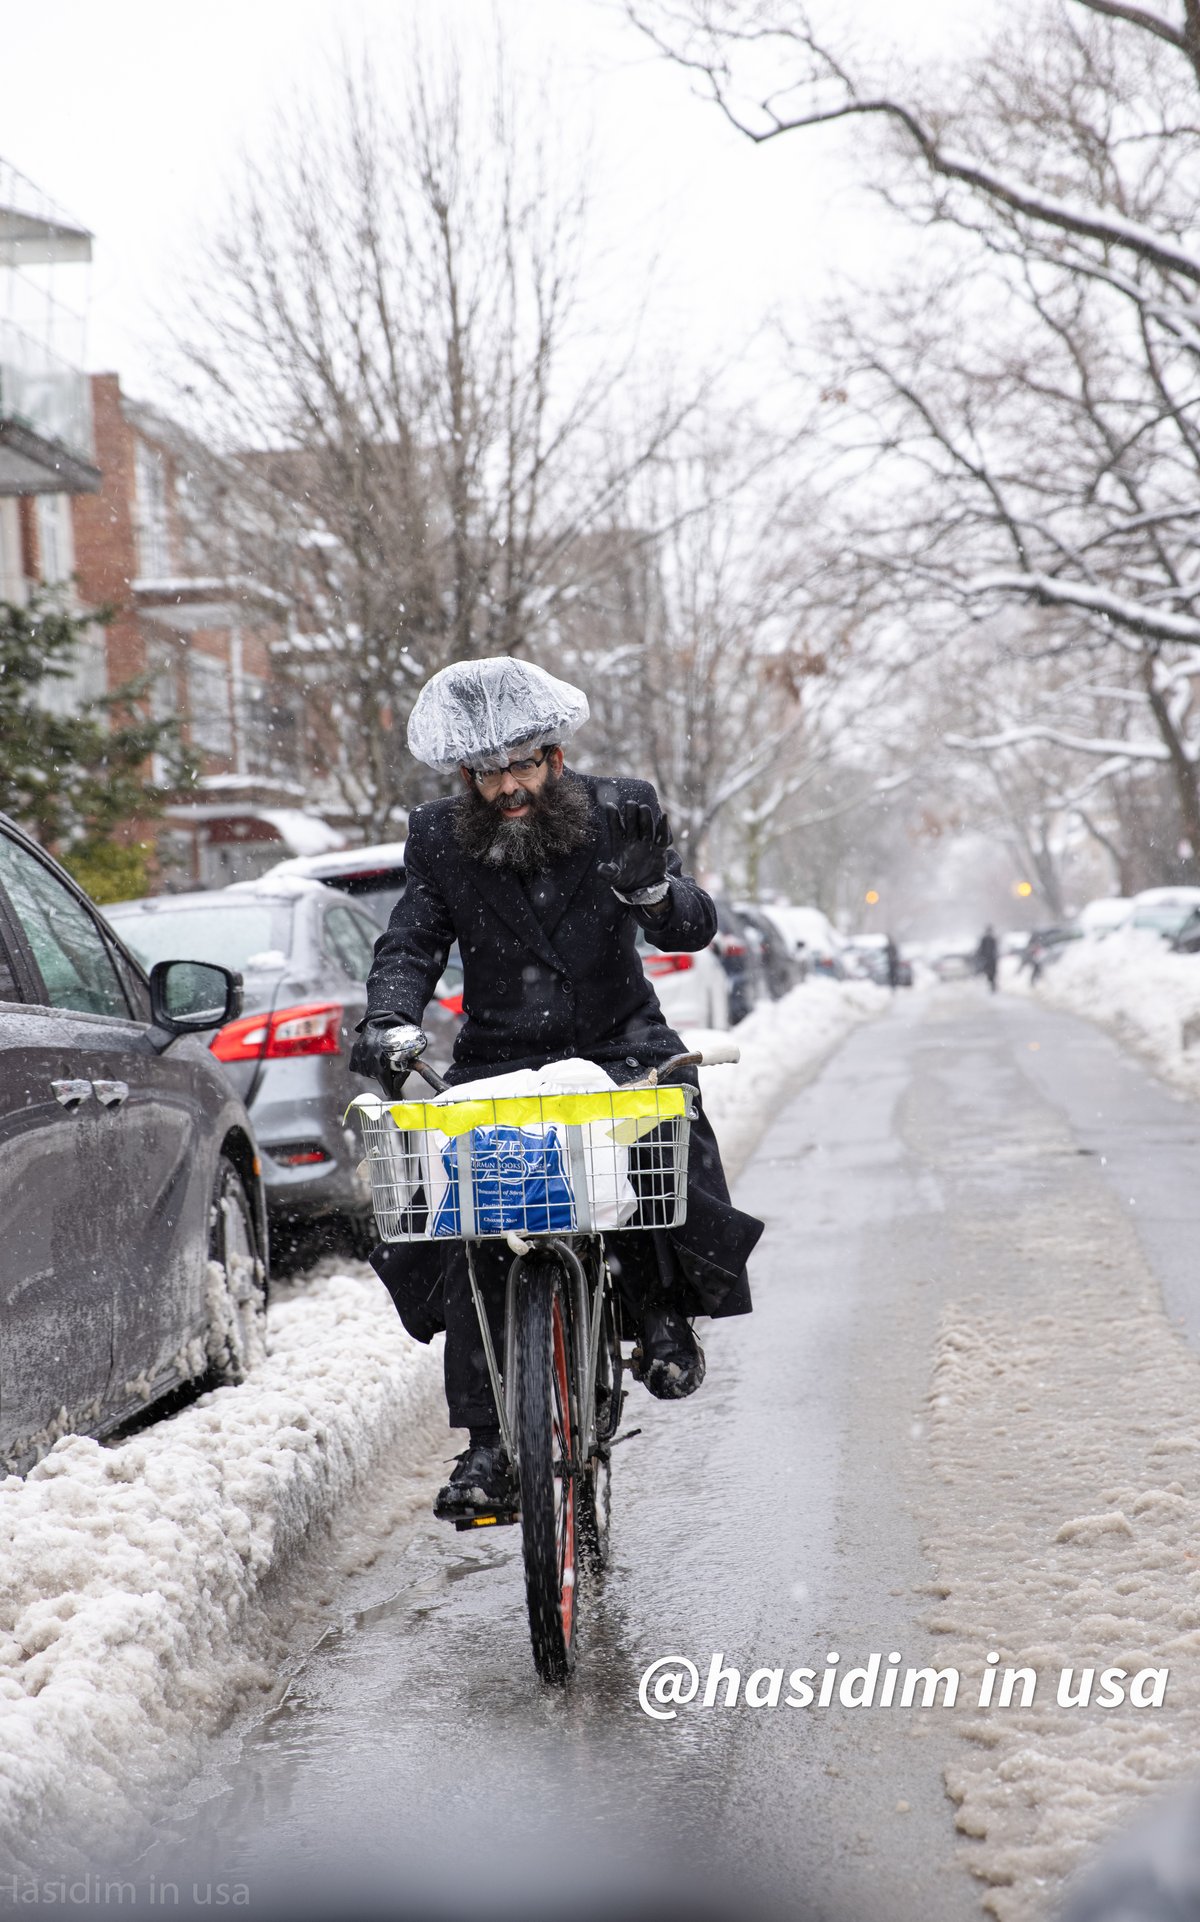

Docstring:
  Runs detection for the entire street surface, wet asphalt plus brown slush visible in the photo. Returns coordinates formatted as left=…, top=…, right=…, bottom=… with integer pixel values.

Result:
left=67, top=984, right=1200, bottom=1922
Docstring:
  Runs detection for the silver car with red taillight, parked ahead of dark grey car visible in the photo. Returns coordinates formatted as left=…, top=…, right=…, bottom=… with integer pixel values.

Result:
left=112, top=875, right=462, bottom=1245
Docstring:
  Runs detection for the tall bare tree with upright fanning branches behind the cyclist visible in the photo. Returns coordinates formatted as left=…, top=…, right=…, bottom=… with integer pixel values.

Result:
left=183, top=43, right=703, bottom=834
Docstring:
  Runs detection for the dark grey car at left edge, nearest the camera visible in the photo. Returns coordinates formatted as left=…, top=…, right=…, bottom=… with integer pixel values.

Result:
left=0, top=817, right=267, bottom=1472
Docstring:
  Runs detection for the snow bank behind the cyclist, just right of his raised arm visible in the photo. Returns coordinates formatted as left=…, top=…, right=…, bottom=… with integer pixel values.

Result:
left=683, top=976, right=890, bottom=1180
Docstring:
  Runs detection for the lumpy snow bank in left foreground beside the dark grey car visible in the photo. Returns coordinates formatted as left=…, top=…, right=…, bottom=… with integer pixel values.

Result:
left=0, top=1267, right=444, bottom=1872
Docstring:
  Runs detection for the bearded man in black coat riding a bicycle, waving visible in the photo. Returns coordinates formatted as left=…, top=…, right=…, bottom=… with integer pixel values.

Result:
left=350, top=655, right=762, bottom=1520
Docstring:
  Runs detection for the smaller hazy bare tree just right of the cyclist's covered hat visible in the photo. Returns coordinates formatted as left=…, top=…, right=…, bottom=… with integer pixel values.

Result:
left=556, top=413, right=915, bottom=892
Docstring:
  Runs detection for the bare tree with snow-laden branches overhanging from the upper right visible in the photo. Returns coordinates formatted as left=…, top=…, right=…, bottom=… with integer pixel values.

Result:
left=631, top=0, right=1200, bottom=880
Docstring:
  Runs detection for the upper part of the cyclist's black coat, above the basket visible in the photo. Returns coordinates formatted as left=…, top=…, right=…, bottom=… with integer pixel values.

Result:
left=367, top=775, right=717, bottom=1080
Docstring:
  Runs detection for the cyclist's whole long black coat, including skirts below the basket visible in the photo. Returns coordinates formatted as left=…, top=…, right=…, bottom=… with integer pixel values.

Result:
left=367, top=775, right=762, bottom=1340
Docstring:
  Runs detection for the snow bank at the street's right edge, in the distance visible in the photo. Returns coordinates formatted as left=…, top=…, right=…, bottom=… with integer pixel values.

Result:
left=1006, top=928, right=1200, bottom=1099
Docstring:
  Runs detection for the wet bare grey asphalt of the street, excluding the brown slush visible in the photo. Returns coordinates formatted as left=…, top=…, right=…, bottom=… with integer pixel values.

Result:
left=156, top=984, right=1200, bottom=1922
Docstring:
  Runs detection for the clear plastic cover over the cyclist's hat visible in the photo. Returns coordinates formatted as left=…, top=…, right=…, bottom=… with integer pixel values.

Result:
left=408, top=653, right=588, bottom=769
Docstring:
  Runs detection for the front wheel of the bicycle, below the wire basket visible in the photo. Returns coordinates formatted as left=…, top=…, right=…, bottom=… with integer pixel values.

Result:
left=515, top=1255, right=579, bottom=1682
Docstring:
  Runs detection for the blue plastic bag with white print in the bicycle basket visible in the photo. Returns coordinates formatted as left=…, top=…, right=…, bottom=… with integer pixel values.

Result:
left=431, top=1126, right=575, bottom=1236
